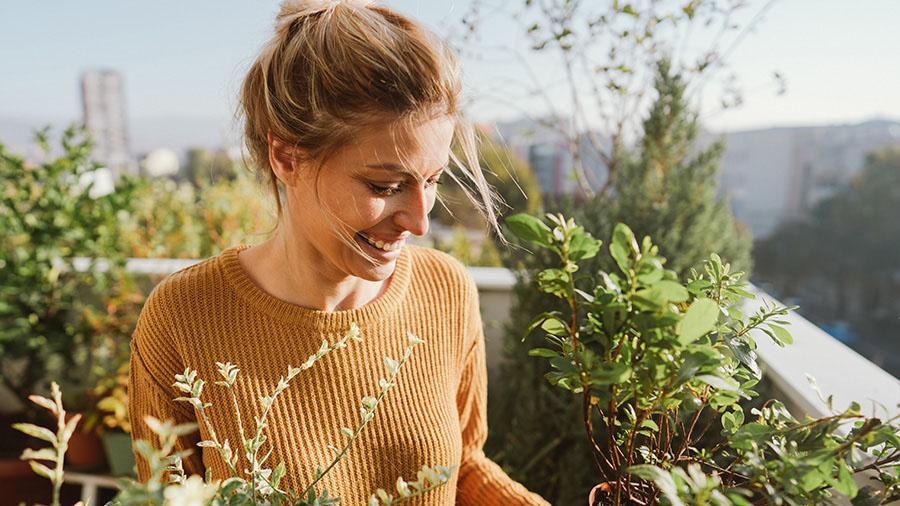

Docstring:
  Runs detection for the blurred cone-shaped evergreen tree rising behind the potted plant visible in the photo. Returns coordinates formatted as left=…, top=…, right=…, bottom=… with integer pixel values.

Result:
left=579, top=60, right=752, bottom=279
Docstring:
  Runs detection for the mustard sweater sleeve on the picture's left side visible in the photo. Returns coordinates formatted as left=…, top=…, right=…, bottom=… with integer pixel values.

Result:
left=128, top=286, right=204, bottom=482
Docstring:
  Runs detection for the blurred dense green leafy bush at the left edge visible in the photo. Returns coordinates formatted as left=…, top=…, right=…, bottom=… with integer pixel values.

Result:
left=0, top=126, right=131, bottom=408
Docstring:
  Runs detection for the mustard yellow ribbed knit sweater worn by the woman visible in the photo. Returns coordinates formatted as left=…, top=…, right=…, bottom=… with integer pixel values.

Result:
left=129, top=246, right=547, bottom=506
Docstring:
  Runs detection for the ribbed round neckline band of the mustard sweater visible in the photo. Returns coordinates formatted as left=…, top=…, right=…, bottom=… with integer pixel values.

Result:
left=219, top=245, right=412, bottom=331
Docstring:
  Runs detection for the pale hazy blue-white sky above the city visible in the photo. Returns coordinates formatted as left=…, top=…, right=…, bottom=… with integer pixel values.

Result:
left=0, top=0, right=900, bottom=150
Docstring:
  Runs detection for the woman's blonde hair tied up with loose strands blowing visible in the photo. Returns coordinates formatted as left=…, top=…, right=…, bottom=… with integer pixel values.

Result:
left=238, top=0, right=500, bottom=234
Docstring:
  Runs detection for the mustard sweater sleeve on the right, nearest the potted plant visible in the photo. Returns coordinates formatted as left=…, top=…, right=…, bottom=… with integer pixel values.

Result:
left=456, top=280, right=549, bottom=506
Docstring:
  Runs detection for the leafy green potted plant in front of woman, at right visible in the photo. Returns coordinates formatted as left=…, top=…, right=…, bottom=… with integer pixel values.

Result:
left=507, top=211, right=900, bottom=506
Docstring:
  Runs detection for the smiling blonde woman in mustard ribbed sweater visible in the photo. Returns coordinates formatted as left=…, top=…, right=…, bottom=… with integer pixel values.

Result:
left=129, top=1, right=546, bottom=505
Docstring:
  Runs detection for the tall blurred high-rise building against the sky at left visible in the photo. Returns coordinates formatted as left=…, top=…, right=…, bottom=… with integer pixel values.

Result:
left=81, top=70, right=138, bottom=177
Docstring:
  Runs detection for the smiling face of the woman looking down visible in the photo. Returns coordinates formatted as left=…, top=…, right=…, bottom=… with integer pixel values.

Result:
left=286, top=118, right=453, bottom=281
